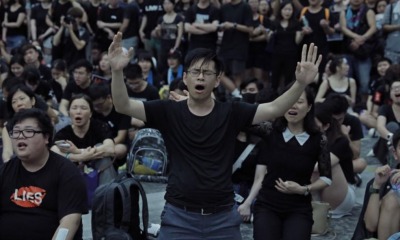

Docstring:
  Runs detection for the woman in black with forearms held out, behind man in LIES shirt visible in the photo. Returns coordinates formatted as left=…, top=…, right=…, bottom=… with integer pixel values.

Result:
left=51, top=94, right=116, bottom=184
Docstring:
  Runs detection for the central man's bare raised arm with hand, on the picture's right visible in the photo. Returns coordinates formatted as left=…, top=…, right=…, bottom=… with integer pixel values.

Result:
left=253, top=43, right=322, bottom=124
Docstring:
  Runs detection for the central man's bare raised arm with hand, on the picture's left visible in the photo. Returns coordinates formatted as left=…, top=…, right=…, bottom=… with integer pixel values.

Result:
left=108, top=32, right=146, bottom=122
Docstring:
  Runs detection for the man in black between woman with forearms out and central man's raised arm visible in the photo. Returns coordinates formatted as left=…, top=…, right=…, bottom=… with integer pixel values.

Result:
left=89, top=83, right=131, bottom=170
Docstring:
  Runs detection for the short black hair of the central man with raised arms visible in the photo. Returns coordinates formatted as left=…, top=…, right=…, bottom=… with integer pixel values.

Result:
left=184, top=48, right=224, bottom=75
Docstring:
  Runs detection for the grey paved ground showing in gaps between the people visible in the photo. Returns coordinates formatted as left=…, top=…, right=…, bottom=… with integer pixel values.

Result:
left=83, top=137, right=379, bottom=240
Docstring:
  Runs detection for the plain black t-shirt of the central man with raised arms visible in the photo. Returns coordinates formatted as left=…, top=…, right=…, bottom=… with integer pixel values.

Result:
left=144, top=100, right=257, bottom=207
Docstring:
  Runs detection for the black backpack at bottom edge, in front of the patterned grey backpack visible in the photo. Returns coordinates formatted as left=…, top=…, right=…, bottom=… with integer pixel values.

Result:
left=92, top=173, right=149, bottom=240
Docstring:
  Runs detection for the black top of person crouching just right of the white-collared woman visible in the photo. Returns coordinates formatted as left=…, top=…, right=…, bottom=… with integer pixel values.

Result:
left=329, top=137, right=356, bottom=184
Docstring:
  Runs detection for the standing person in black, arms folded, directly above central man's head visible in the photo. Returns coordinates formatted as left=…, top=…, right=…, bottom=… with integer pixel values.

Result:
left=184, top=0, right=219, bottom=51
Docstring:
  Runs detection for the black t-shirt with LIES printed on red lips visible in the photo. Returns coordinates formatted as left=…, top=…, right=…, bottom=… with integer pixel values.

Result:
left=0, top=151, right=88, bottom=240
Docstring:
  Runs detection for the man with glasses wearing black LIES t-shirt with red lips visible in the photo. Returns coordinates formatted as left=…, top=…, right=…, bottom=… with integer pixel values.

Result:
left=0, top=108, right=88, bottom=240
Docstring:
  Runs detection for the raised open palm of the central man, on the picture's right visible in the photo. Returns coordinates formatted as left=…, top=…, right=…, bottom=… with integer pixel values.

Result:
left=296, top=43, right=322, bottom=85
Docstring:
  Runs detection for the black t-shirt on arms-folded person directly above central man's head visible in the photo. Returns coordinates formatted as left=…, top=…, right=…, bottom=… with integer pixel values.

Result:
left=185, top=4, right=220, bottom=49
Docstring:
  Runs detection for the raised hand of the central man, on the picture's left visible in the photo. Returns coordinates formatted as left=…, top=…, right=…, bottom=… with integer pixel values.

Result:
left=108, top=32, right=134, bottom=70
